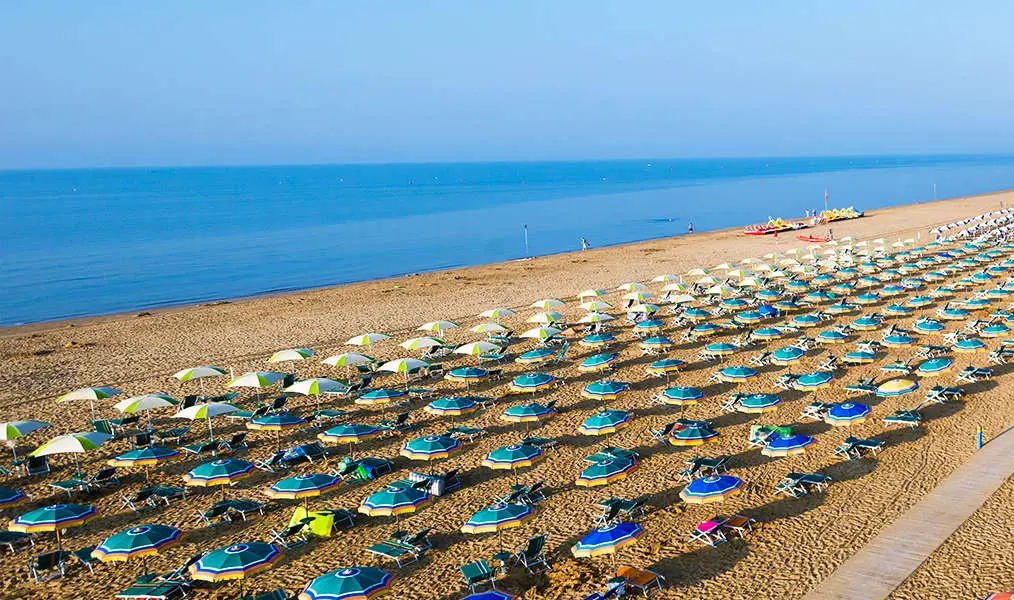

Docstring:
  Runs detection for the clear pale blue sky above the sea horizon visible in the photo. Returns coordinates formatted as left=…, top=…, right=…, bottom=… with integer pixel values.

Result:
left=0, top=0, right=1014, bottom=168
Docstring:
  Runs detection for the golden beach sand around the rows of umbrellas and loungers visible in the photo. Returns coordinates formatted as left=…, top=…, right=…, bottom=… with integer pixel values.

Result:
left=0, top=193, right=1014, bottom=600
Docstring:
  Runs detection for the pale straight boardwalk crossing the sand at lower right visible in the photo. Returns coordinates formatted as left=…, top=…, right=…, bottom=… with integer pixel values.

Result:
left=804, top=429, right=1014, bottom=600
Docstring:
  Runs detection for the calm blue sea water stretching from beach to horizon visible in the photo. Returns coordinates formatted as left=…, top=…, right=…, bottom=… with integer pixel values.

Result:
left=0, top=156, right=1014, bottom=325
